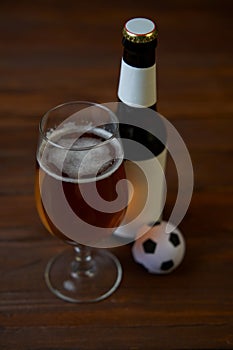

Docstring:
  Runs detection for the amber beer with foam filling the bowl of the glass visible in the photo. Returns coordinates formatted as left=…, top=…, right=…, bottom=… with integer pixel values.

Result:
left=35, top=128, right=127, bottom=243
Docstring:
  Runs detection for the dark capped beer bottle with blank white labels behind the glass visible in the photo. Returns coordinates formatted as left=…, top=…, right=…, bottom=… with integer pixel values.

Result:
left=116, top=18, right=166, bottom=239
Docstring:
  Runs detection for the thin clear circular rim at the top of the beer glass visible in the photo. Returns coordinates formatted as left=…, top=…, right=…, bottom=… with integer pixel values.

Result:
left=39, top=100, right=119, bottom=151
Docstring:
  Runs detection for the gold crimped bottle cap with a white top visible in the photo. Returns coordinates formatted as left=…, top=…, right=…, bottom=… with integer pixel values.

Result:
left=122, top=18, right=158, bottom=43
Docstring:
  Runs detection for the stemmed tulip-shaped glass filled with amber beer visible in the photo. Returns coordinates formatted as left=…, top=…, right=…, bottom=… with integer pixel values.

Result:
left=35, top=101, right=128, bottom=303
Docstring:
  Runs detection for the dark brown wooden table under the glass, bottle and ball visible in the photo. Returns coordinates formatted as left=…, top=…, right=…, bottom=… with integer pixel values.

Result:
left=0, top=0, right=233, bottom=350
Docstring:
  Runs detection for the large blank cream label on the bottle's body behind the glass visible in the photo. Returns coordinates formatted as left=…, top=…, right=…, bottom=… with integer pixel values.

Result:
left=115, top=148, right=167, bottom=240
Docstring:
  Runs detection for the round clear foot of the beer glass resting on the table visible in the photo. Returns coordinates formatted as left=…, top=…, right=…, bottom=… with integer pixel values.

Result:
left=45, top=247, right=122, bottom=303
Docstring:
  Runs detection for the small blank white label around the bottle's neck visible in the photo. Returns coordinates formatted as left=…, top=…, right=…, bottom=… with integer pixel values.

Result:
left=118, top=59, right=157, bottom=107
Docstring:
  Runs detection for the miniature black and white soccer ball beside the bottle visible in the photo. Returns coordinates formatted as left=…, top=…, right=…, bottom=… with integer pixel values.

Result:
left=132, top=221, right=185, bottom=274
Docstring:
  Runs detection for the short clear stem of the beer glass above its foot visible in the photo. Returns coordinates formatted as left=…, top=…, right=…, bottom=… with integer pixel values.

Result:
left=71, top=244, right=95, bottom=278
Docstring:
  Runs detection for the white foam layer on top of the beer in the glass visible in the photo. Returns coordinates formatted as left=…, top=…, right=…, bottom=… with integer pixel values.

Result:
left=38, top=123, right=123, bottom=183
